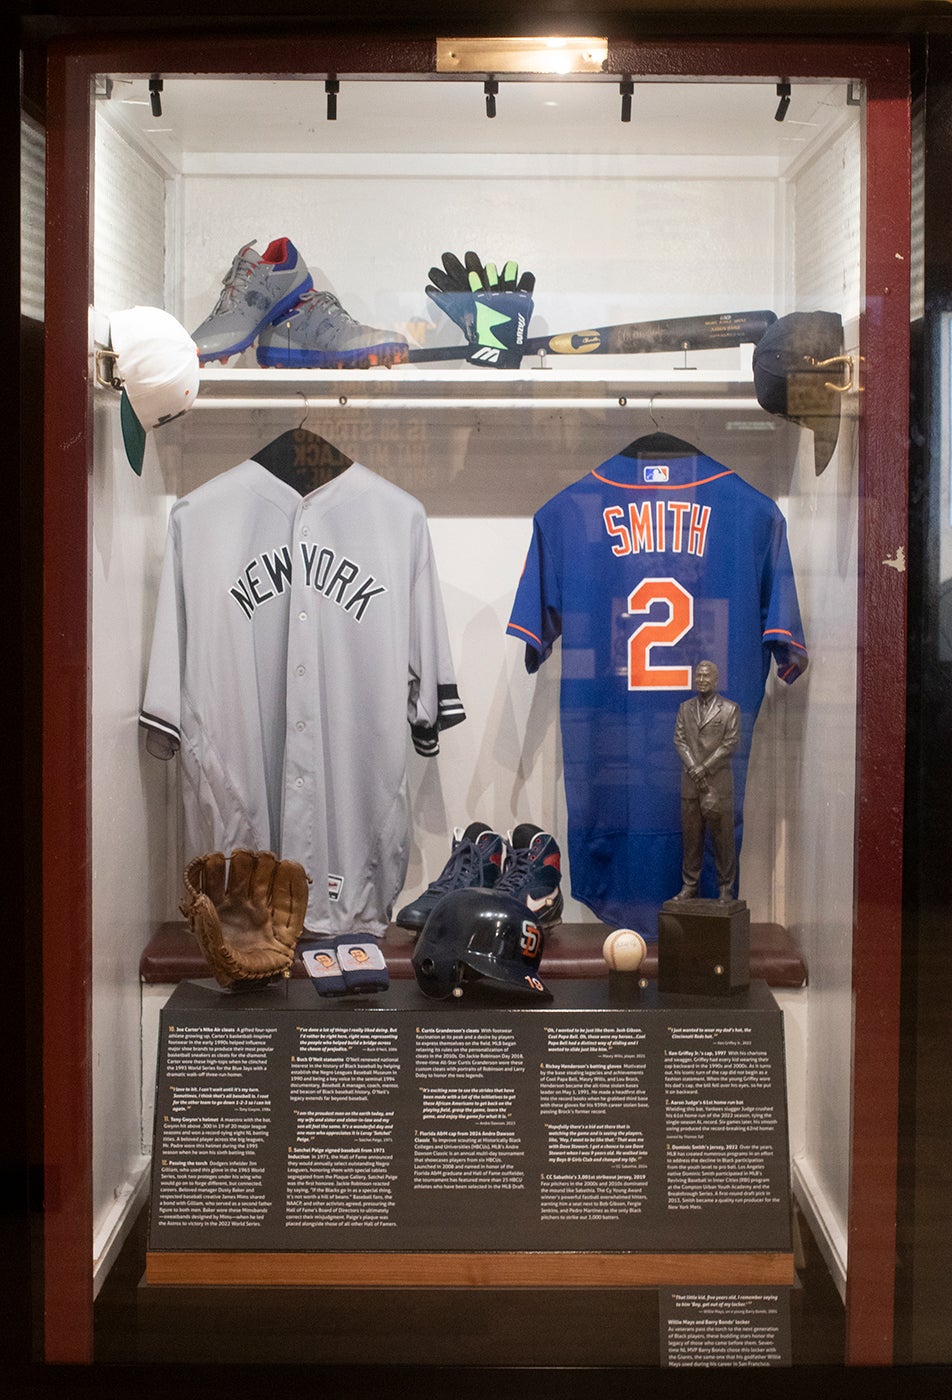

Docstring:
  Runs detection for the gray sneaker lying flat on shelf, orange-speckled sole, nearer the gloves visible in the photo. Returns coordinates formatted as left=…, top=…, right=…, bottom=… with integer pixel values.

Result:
left=258, top=290, right=407, bottom=370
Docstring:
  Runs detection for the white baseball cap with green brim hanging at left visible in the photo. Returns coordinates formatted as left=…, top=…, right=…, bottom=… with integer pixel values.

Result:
left=109, top=307, right=199, bottom=476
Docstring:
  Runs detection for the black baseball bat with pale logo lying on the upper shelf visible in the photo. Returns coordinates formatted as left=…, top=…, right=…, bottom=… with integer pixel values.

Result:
left=393, top=311, right=777, bottom=364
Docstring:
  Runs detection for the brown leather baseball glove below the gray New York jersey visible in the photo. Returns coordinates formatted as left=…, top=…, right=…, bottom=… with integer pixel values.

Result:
left=179, top=850, right=308, bottom=991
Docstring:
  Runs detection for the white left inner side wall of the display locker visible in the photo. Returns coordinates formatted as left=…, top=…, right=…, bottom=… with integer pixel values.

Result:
left=91, top=109, right=181, bottom=1287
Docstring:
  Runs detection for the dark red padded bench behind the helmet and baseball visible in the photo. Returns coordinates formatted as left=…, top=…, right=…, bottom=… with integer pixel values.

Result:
left=139, top=920, right=806, bottom=987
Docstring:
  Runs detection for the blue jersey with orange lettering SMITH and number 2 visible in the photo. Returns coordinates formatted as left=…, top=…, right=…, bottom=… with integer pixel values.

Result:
left=507, top=454, right=806, bottom=938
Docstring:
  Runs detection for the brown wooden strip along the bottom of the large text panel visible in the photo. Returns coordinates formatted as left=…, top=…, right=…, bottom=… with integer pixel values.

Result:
left=146, top=1250, right=794, bottom=1288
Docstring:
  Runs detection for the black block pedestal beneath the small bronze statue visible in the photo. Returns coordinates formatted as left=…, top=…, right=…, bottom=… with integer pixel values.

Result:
left=658, top=899, right=750, bottom=997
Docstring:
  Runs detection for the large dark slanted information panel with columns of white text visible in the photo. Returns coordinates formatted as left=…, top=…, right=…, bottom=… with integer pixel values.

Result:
left=150, top=980, right=791, bottom=1253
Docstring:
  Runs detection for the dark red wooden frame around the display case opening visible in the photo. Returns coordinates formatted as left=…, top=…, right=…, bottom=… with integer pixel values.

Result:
left=42, top=31, right=910, bottom=1365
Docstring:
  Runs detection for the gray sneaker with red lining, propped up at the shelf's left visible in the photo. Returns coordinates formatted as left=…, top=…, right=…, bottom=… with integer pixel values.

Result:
left=192, top=238, right=314, bottom=364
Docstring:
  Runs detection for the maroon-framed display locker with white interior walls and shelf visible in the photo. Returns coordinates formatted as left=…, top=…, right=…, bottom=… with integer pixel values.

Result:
left=43, top=36, right=910, bottom=1361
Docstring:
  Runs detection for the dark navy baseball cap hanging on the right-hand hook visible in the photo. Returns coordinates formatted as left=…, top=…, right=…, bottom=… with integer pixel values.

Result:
left=753, top=311, right=843, bottom=476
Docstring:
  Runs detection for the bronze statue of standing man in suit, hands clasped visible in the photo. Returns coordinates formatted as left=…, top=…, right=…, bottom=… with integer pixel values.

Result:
left=675, top=661, right=741, bottom=903
